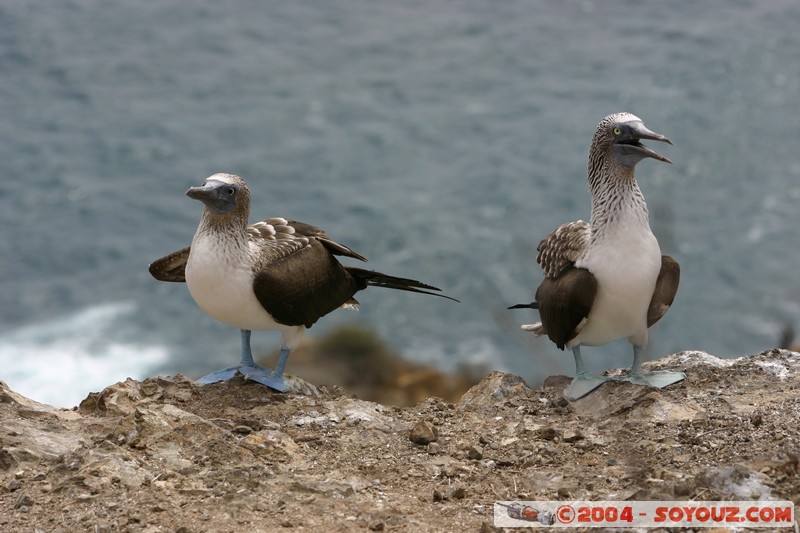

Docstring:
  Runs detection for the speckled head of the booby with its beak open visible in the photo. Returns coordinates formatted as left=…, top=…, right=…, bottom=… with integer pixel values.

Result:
left=589, top=112, right=672, bottom=168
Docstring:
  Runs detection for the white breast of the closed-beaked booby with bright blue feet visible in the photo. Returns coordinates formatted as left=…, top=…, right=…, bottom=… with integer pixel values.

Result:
left=186, top=234, right=287, bottom=330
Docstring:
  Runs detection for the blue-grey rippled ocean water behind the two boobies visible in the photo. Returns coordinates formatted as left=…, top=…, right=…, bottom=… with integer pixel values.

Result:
left=0, top=0, right=800, bottom=406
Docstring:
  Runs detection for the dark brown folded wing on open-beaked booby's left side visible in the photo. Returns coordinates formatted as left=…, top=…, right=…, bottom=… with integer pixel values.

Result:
left=536, top=266, right=597, bottom=350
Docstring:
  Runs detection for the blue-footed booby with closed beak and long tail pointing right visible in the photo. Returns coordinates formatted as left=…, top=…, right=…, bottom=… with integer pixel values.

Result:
left=150, top=174, right=457, bottom=392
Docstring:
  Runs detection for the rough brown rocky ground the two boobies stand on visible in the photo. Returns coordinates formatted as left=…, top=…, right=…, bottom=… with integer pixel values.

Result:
left=0, top=350, right=800, bottom=533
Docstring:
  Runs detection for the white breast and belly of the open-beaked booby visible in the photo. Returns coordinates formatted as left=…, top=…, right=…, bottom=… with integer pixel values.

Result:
left=568, top=214, right=661, bottom=348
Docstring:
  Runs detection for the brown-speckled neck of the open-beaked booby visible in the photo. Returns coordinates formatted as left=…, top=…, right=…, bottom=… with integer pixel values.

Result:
left=589, top=154, right=649, bottom=235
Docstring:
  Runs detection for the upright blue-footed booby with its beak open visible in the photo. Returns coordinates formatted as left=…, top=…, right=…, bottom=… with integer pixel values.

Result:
left=509, top=113, right=686, bottom=400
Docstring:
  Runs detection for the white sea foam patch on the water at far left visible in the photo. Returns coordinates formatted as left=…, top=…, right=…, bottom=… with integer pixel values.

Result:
left=0, top=303, right=168, bottom=407
